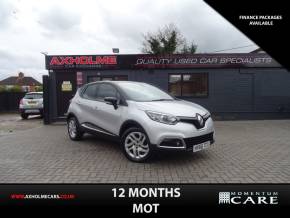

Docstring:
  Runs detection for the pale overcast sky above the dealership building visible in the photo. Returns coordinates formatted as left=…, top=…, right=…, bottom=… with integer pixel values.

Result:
left=0, top=0, right=257, bottom=81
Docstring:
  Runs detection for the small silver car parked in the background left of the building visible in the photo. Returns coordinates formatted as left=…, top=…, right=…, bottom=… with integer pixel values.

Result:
left=19, top=92, right=43, bottom=119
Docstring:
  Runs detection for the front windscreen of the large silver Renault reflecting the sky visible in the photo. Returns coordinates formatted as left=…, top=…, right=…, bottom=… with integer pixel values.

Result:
left=119, top=82, right=174, bottom=101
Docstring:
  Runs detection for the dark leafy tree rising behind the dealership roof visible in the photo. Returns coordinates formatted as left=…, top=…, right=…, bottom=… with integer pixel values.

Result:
left=142, top=23, right=197, bottom=55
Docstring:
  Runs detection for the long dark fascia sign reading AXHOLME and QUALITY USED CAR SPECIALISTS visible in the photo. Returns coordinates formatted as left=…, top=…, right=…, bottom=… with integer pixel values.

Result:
left=46, top=54, right=280, bottom=69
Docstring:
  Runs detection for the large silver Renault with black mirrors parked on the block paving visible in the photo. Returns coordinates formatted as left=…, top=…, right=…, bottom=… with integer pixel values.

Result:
left=67, top=81, right=214, bottom=162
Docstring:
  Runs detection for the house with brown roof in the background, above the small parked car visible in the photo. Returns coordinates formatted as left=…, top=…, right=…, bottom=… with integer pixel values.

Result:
left=0, top=72, right=42, bottom=92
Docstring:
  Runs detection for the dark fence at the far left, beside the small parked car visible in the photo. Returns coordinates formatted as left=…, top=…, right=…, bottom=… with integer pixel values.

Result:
left=0, top=92, right=25, bottom=112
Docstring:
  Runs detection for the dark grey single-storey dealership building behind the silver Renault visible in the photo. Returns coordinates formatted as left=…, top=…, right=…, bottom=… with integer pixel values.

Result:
left=43, top=53, right=290, bottom=123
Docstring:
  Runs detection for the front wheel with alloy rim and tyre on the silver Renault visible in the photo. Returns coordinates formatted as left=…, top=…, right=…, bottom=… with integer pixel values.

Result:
left=121, top=127, right=154, bottom=162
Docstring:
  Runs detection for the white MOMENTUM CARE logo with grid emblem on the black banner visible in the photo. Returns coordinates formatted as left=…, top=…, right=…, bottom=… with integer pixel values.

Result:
left=219, top=191, right=279, bottom=205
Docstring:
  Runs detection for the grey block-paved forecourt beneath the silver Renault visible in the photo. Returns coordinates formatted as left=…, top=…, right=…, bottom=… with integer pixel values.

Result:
left=0, top=120, right=290, bottom=183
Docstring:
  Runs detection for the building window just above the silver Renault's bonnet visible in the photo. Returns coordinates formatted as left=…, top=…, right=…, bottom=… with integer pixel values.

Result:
left=169, top=73, right=208, bottom=97
